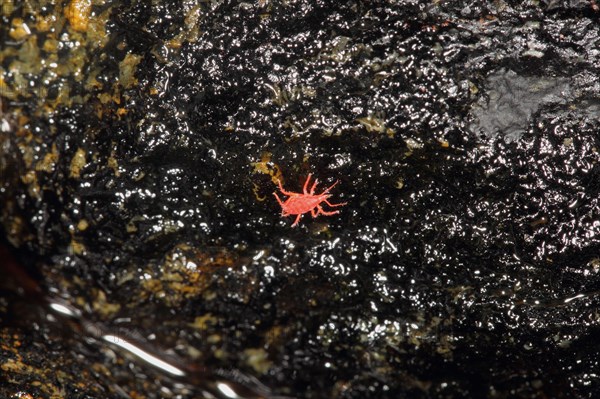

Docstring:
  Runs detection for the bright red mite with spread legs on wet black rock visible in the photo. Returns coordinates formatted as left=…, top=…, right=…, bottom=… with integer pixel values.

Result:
left=273, top=174, right=346, bottom=227
